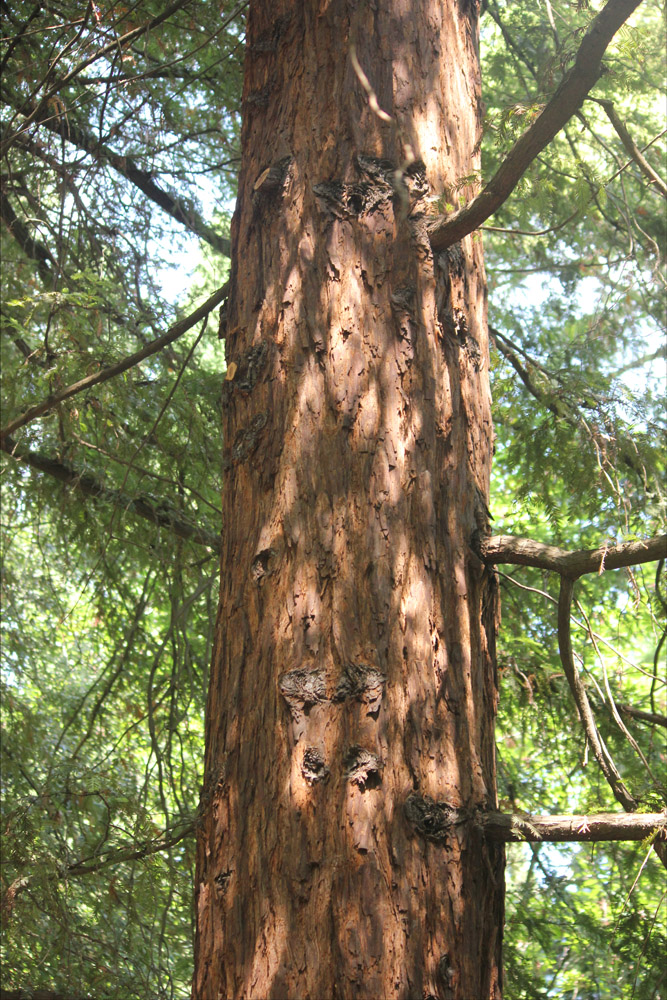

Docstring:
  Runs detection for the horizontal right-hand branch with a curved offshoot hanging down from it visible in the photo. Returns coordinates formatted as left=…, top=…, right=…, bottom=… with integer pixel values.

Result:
left=481, top=535, right=667, bottom=580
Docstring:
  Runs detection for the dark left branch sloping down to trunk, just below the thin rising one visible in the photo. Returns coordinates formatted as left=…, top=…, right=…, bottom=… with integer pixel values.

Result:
left=0, top=437, right=220, bottom=552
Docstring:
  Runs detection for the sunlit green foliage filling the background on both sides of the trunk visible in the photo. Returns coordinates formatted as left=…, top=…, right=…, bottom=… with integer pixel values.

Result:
left=2, top=0, right=665, bottom=997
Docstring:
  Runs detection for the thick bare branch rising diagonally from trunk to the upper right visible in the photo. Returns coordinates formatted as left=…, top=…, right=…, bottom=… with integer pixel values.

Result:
left=429, top=0, right=641, bottom=252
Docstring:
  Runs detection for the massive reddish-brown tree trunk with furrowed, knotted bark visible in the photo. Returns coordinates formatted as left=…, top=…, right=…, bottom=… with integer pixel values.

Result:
left=193, top=0, right=503, bottom=1000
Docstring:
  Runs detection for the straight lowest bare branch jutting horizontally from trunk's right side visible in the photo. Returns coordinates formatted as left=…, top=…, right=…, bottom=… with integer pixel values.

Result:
left=482, top=812, right=667, bottom=843
